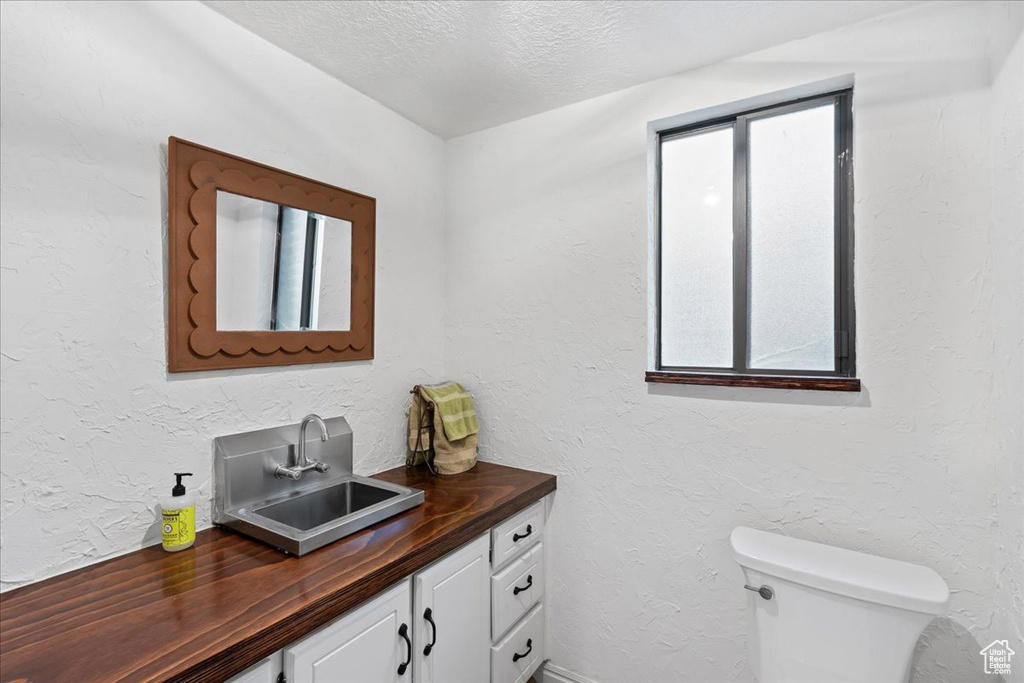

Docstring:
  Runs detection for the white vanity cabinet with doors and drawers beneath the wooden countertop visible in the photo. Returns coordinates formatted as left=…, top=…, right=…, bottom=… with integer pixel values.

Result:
left=229, top=500, right=545, bottom=683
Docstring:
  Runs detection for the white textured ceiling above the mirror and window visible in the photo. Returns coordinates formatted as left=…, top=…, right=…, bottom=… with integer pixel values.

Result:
left=205, top=0, right=914, bottom=138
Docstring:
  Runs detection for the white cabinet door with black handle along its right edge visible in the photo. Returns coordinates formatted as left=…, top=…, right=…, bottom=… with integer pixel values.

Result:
left=285, top=580, right=411, bottom=683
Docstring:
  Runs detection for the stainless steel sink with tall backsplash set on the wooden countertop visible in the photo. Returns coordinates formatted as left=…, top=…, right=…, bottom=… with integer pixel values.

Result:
left=214, top=418, right=423, bottom=555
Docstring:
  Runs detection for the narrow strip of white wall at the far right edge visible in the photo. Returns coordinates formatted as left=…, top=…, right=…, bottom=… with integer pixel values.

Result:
left=989, top=2, right=1024, bottom=681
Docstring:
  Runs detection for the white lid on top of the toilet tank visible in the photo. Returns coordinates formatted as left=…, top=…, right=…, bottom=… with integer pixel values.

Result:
left=730, top=526, right=949, bottom=614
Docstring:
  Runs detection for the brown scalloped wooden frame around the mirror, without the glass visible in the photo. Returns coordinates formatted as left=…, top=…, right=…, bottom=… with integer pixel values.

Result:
left=167, top=137, right=377, bottom=373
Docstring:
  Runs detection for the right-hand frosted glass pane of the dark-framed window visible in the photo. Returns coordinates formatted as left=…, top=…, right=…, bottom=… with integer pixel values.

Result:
left=748, top=102, right=836, bottom=371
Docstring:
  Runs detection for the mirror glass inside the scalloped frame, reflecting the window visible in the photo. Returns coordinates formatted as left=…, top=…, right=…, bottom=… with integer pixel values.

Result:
left=217, top=189, right=352, bottom=332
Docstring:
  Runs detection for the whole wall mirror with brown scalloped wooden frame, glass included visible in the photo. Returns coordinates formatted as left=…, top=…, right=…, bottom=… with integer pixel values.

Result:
left=167, top=137, right=377, bottom=373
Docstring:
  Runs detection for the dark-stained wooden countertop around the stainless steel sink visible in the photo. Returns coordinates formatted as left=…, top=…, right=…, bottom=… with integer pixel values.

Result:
left=0, top=462, right=556, bottom=683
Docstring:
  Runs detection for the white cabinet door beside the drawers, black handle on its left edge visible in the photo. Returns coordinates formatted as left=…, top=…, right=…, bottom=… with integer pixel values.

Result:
left=413, top=536, right=490, bottom=683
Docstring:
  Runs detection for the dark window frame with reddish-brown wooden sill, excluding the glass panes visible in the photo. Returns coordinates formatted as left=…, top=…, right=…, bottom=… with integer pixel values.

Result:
left=646, top=88, right=860, bottom=391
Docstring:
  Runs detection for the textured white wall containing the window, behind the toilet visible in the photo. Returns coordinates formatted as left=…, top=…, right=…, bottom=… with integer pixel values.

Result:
left=445, top=3, right=1019, bottom=683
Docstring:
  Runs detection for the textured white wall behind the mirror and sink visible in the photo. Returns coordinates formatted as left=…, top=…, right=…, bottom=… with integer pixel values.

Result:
left=0, top=2, right=444, bottom=588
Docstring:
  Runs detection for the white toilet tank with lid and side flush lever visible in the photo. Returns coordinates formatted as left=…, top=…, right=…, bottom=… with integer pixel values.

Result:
left=730, top=526, right=949, bottom=683
